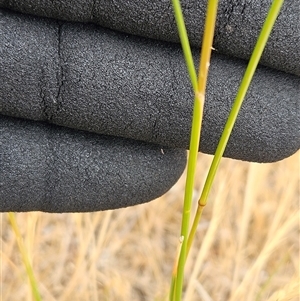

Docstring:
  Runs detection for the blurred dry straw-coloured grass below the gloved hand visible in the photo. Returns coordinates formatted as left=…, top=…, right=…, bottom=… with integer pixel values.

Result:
left=1, top=152, right=300, bottom=301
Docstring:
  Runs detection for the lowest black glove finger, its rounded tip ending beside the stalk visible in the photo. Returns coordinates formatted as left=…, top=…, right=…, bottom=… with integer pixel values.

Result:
left=0, top=115, right=186, bottom=212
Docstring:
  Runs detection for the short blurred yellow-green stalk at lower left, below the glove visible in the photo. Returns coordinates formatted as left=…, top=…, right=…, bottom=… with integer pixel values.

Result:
left=8, top=212, right=42, bottom=301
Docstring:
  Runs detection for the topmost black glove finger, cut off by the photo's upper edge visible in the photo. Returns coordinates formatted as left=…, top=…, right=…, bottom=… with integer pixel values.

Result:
left=0, top=0, right=300, bottom=76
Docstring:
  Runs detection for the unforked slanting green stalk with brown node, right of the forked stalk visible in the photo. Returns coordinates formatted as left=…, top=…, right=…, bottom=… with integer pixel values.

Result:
left=188, top=0, right=284, bottom=250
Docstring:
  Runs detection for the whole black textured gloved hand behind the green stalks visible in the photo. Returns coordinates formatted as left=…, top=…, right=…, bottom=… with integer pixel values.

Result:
left=0, top=0, right=300, bottom=212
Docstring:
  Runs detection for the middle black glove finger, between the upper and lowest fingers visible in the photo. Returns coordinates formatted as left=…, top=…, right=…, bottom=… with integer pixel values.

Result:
left=0, top=11, right=300, bottom=162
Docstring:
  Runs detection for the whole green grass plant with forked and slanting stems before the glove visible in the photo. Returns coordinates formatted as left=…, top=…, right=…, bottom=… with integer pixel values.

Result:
left=170, top=0, right=284, bottom=301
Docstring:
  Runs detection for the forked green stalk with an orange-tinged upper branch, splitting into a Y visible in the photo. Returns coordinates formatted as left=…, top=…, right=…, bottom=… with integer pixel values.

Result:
left=170, top=0, right=218, bottom=301
